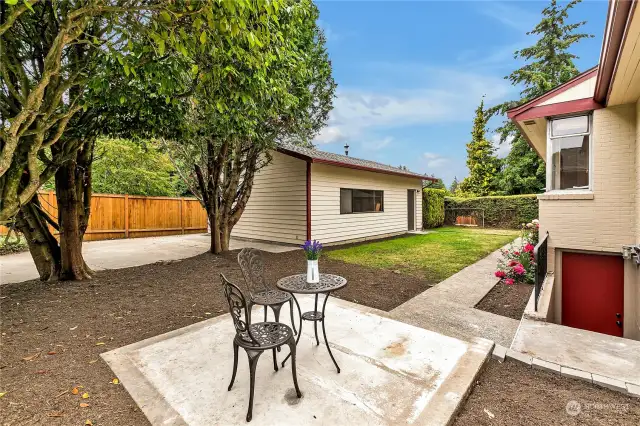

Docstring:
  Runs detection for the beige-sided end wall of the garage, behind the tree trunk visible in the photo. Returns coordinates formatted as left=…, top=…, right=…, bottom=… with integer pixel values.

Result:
left=231, top=152, right=307, bottom=244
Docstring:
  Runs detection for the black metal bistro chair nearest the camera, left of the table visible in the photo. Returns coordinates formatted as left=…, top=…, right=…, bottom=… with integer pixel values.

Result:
left=220, top=274, right=302, bottom=422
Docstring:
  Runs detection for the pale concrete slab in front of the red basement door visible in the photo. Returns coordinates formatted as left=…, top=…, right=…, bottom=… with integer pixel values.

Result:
left=511, top=319, right=640, bottom=385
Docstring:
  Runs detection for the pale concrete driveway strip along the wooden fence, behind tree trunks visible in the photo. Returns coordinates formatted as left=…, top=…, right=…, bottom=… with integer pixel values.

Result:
left=0, top=234, right=297, bottom=284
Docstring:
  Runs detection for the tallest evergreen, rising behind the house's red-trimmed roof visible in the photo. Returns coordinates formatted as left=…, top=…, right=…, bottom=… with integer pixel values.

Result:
left=488, top=0, right=593, bottom=194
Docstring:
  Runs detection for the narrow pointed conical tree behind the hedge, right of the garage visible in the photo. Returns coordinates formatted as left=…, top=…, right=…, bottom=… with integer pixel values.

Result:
left=457, top=99, right=500, bottom=197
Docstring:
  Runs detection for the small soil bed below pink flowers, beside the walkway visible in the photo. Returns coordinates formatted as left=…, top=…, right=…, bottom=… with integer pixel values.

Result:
left=475, top=282, right=533, bottom=320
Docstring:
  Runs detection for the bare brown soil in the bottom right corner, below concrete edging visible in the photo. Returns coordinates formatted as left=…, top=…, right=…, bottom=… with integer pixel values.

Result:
left=453, top=360, right=640, bottom=426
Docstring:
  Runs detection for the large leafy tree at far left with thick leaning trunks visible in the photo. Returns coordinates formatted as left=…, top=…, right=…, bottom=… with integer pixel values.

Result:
left=0, top=0, right=254, bottom=279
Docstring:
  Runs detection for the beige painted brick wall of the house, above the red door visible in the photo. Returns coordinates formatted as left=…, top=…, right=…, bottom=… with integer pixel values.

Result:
left=540, top=104, right=640, bottom=269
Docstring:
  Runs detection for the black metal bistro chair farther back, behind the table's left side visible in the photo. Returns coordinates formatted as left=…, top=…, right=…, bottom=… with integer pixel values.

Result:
left=238, top=247, right=298, bottom=334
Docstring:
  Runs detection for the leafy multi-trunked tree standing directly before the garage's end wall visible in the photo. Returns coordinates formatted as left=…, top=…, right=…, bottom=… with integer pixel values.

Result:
left=167, top=0, right=335, bottom=253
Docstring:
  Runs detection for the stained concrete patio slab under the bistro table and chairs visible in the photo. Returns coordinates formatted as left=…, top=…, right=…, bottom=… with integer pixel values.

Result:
left=102, top=297, right=493, bottom=425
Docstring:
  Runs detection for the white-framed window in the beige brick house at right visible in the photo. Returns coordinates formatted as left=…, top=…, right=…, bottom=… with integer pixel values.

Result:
left=547, top=115, right=592, bottom=190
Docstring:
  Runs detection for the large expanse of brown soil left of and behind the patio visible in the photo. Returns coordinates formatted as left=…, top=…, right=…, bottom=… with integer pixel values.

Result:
left=0, top=251, right=430, bottom=426
